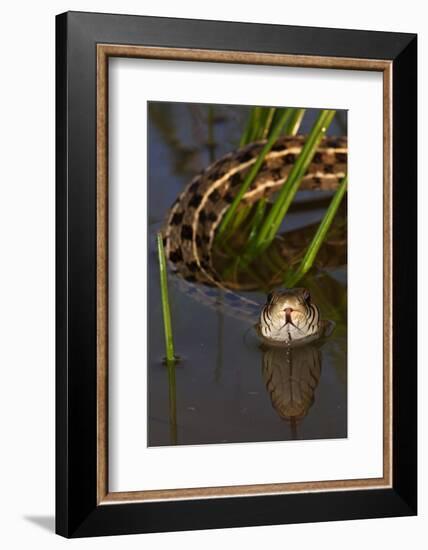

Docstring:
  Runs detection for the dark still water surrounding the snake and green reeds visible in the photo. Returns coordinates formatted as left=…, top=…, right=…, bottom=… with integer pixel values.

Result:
left=148, top=102, right=347, bottom=446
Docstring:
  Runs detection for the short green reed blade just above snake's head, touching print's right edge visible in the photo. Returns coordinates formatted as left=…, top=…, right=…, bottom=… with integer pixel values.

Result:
left=284, top=176, right=348, bottom=287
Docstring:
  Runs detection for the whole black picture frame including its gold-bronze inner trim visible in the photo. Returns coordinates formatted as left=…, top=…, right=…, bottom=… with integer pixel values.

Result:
left=56, top=12, right=417, bottom=537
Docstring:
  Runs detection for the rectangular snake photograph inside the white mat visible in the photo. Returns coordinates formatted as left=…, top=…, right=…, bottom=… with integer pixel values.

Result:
left=147, top=101, right=352, bottom=447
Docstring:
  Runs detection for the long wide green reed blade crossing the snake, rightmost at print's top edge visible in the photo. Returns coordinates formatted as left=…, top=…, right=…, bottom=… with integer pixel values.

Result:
left=249, top=110, right=336, bottom=256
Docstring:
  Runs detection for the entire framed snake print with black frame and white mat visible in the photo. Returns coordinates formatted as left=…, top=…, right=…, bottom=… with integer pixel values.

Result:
left=56, top=12, right=417, bottom=537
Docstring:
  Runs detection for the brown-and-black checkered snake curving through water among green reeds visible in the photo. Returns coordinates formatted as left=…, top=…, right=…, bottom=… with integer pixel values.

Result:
left=162, top=135, right=348, bottom=343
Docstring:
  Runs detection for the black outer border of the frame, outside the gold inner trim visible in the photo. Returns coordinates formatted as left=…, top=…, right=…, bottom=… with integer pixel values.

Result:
left=56, top=12, right=417, bottom=537
